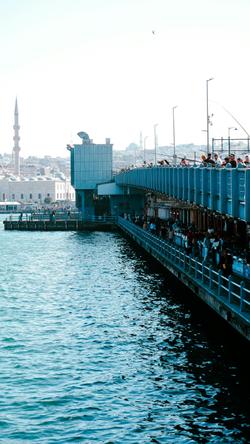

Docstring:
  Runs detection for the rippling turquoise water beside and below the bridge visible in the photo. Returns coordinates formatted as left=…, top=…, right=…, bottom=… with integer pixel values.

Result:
left=0, top=219, right=249, bottom=444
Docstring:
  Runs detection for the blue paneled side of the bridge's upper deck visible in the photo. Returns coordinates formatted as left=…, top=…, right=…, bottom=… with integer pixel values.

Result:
left=115, top=166, right=250, bottom=222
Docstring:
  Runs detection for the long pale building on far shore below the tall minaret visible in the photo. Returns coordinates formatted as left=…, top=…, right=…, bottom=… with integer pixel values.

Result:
left=0, top=176, right=75, bottom=205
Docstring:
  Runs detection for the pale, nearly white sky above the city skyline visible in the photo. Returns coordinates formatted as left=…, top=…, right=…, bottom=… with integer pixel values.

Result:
left=0, top=0, right=250, bottom=156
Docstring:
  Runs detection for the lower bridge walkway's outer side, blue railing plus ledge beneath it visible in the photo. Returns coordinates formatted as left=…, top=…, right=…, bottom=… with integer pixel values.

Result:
left=117, top=217, right=250, bottom=340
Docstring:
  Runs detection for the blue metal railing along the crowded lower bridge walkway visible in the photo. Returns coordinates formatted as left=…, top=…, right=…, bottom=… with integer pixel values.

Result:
left=117, top=217, right=250, bottom=322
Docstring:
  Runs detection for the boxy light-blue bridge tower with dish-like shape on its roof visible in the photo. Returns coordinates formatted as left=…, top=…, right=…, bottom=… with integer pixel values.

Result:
left=67, top=131, right=113, bottom=216
